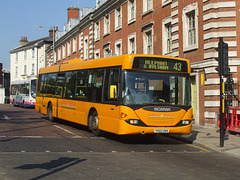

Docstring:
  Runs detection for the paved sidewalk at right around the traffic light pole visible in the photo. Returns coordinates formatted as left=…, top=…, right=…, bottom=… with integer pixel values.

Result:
left=175, top=124, right=240, bottom=157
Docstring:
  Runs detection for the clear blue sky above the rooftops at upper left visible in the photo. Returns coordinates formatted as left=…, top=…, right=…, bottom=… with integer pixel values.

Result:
left=0, top=0, right=96, bottom=71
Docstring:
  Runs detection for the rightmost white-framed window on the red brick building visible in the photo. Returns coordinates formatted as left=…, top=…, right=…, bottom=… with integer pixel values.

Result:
left=183, top=2, right=198, bottom=51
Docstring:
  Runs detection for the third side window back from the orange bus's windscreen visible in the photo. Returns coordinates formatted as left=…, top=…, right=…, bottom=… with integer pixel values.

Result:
left=76, top=71, right=88, bottom=100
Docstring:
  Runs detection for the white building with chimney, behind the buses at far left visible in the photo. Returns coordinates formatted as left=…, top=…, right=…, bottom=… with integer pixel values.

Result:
left=9, top=35, right=52, bottom=82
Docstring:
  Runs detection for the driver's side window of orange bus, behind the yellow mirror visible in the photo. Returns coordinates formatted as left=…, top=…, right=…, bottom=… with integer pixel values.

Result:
left=104, top=69, right=120, bottom=101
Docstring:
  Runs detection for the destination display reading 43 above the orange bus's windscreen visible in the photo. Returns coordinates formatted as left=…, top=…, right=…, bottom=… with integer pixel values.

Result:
left=133, top=57, right=188, bottom=72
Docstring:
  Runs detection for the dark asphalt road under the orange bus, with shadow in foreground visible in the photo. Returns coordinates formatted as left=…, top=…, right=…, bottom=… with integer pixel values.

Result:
left=0, top=105, right=240, bottom=180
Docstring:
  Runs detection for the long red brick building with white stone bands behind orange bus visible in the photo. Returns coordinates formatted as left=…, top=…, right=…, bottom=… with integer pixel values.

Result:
left=48, top=0, right=240, bottom=126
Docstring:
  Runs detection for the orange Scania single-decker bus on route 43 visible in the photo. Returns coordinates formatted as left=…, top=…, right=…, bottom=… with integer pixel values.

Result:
left=35, top=55, right=193, bottom=135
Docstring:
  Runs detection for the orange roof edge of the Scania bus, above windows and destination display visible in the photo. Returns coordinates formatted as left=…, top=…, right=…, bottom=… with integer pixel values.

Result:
left=39, top=54, right=191, bottom=74
